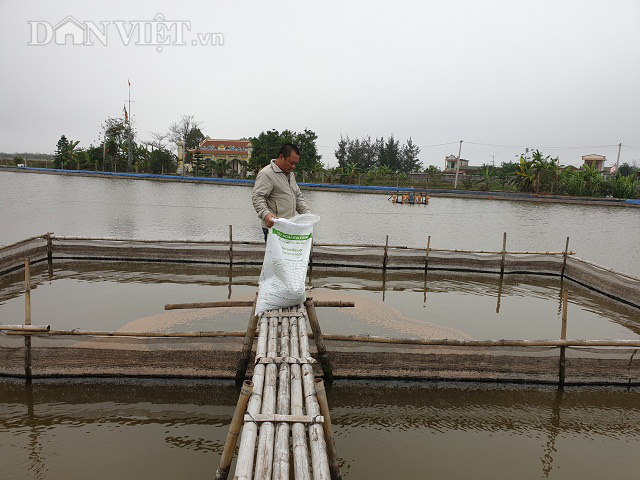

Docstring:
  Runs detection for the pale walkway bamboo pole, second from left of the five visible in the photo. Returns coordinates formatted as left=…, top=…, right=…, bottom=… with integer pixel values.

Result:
left=254, top=317, right=278, bottom=480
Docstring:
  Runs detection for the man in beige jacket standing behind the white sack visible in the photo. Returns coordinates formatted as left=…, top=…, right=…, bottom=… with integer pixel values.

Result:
left=251, top=143, right=309, bottom=241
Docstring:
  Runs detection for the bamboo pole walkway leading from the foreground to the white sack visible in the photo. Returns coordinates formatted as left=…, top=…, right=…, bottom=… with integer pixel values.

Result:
left=216, top=301, right=341, bottom=480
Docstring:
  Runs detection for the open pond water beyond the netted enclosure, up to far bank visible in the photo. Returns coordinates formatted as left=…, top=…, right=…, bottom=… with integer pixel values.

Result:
left=0, top=171, right=640, bottom=277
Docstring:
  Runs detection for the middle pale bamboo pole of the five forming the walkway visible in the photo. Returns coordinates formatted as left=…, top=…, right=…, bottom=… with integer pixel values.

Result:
left=273, top=317, right=291, bottom=480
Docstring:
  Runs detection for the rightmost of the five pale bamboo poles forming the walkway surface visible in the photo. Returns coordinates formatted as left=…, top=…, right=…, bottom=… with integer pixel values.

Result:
left=298, top=308, right=331, bottom=480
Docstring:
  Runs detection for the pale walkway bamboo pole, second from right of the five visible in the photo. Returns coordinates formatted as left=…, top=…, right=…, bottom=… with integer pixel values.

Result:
left=289, top=317, right=311, bottom=480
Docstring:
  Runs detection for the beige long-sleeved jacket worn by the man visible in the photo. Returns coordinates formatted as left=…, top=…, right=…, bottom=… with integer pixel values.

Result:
left=251, top=160, right=309, bottom=228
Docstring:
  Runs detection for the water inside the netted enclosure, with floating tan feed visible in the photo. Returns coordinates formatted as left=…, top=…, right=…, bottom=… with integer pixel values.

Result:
left=0, top=262, right=640, bottom=339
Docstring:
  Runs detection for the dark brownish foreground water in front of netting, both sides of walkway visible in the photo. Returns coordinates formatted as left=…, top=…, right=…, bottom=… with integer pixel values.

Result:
left=0, top=380, right=640, bottom=479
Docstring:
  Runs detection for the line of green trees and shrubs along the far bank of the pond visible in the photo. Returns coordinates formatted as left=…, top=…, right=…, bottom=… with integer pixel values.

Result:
left=46, top=119, right=640, bottom=198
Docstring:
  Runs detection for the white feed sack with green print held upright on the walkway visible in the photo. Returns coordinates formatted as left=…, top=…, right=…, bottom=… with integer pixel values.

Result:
left=256, top=213, right=320, bottom=315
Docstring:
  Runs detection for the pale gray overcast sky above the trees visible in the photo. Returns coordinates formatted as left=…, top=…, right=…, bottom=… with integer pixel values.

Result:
left=0, top=0, right=640, bottom=167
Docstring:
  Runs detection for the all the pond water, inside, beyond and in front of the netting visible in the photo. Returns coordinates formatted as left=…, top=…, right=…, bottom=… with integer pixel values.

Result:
left=0, top=172, right=640, bottom=479
